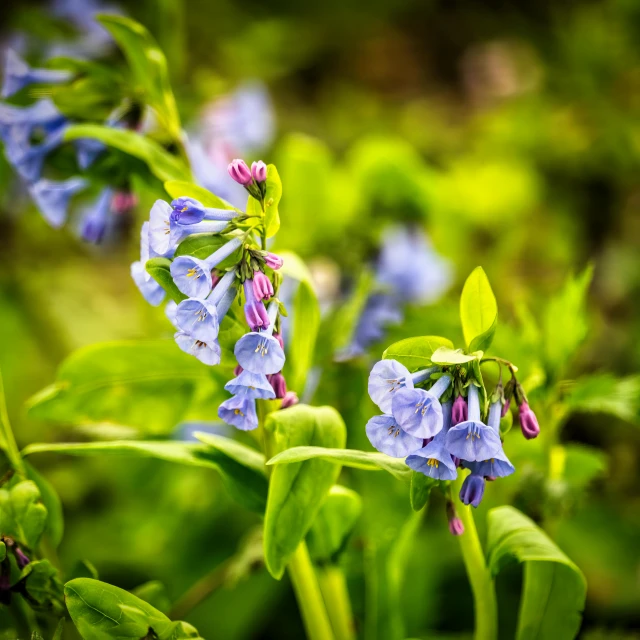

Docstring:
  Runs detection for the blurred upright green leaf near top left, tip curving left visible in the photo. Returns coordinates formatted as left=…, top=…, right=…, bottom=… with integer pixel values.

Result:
left=97, top=14, right=182, bottom=139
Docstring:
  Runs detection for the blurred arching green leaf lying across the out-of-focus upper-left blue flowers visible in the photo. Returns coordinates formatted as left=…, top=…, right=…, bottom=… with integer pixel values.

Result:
left=64, top=124, right=190, bottom=181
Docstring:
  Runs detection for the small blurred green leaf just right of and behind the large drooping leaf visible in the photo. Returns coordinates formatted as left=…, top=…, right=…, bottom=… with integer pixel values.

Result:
left=307, top=485, right=362, bottom=562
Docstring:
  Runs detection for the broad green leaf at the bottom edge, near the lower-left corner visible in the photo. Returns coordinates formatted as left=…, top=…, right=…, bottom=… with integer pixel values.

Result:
left=64, top=578, right=199, bottom=640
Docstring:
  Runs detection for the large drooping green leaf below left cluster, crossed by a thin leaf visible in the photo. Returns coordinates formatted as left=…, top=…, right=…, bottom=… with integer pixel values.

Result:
left=264, top=404, right=347, bottom=579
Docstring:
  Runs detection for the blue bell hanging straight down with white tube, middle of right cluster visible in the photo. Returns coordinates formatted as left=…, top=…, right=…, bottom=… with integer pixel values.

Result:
left=447, top=383, right=502, bottom=462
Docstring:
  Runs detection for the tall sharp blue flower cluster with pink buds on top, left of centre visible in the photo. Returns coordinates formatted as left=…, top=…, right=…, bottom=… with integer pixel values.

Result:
left=131, top=160, right=297, bottom=431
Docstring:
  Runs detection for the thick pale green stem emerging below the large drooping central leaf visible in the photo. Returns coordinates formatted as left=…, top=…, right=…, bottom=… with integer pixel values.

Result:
left=288, top=540, right=334, bottom=640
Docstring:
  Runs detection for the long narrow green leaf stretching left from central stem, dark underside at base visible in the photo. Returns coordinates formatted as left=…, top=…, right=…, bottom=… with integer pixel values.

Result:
left=23, top=440, right=267, bottom=512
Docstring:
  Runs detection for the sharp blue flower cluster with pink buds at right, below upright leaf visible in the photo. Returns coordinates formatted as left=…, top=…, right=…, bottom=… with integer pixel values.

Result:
left=366, top=360, right=540, bottom=533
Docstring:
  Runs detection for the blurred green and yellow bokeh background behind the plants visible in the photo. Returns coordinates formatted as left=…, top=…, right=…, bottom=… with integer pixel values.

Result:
left=0, top=0, right=640, bottom=640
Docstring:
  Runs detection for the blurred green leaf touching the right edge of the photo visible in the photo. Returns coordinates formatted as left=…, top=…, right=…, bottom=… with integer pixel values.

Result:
left=565, top=373, right=640, bottom=422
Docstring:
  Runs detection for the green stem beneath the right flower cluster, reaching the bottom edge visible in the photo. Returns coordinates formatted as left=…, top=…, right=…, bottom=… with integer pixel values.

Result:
left=454, top=474, right=498, bottom=640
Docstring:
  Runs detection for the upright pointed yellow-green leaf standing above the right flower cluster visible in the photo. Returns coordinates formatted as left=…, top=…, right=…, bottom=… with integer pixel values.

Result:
left=460, top=267, right=498, bottom=351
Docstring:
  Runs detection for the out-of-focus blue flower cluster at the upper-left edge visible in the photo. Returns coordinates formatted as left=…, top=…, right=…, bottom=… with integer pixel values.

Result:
left=0, top=50, right=135, bottom=243
